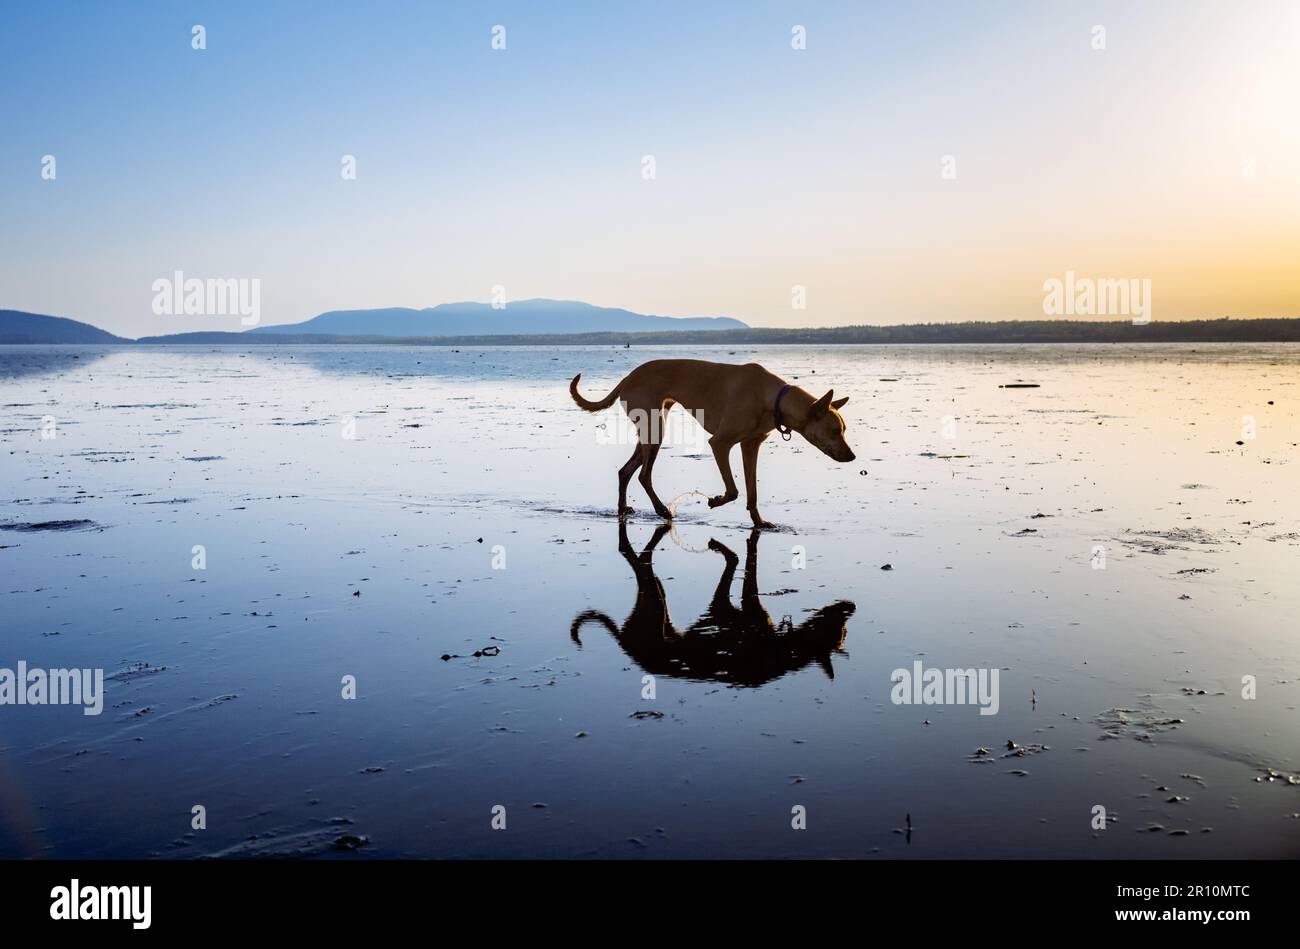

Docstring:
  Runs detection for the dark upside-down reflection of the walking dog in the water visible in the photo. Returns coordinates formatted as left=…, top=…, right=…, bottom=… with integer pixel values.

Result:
left=569, top=521, right=854, bottom=688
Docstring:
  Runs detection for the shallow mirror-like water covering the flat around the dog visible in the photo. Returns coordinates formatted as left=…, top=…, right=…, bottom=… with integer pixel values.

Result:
left=0, top=346, right=1300, bottom=859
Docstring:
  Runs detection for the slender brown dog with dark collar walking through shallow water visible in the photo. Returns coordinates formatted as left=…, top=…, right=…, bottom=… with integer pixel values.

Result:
left=569, top=359, right=854, bottom=528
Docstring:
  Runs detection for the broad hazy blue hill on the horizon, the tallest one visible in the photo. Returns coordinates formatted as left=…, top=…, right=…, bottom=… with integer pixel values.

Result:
left=248, top=300, right=746, bottom=337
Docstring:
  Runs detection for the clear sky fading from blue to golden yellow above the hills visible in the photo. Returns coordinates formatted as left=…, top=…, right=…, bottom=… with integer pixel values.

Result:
left=0, top=0, right=1300, bottom=337
